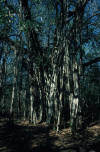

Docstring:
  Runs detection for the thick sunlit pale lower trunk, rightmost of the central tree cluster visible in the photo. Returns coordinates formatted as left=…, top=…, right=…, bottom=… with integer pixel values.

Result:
left=69, top=56, right=80, bottom=134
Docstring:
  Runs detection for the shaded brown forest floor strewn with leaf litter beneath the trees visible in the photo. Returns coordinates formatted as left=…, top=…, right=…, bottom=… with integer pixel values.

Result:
left=0, top=119, right=100, bottom=152
